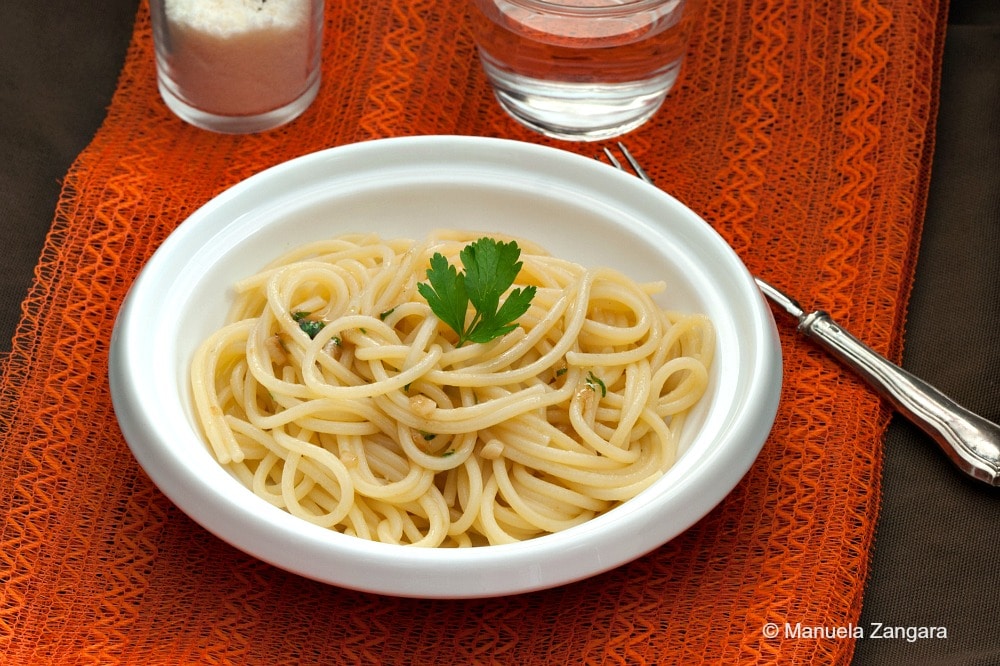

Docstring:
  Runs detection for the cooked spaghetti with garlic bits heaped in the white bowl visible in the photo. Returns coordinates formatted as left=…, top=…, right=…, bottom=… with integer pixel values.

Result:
left=191, top=232, right=715, bottom=546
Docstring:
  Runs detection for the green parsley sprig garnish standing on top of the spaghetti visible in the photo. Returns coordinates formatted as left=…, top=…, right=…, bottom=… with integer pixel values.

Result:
left=417, top=238, right=535, bottom=347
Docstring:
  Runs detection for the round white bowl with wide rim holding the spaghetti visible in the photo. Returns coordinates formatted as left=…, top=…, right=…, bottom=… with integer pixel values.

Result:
left=109, top=136, right=781, bottom=598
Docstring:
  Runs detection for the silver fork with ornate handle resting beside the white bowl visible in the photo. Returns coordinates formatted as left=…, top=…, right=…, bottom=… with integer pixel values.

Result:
left=598, top=142, right=1000, bottom=486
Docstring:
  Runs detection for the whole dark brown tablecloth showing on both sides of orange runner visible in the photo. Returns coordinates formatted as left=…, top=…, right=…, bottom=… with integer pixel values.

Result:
left=0, top=0, right=1000, bottom=666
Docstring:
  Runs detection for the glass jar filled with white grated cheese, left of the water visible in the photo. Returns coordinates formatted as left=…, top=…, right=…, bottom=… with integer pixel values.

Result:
left=149, top=0, right=324, bottom=134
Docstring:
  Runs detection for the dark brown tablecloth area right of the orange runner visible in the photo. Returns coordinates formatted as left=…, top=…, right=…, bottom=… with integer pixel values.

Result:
left=855, top=0, right=1000, bottom=666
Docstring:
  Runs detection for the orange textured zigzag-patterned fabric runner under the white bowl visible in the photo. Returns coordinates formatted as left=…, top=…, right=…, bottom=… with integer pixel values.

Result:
left=0, top=0, right=946, bottom=664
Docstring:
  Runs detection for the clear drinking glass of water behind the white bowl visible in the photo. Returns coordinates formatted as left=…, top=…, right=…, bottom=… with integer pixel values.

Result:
left=472, top=0, right=700, bottom=141
